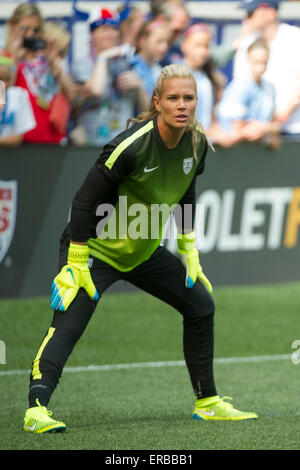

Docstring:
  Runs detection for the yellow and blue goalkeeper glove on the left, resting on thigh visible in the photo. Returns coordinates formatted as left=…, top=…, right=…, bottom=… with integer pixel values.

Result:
left=50, top=243, right=99, bottom=312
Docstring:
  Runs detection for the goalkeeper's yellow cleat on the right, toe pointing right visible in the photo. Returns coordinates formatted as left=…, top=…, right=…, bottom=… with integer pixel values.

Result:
left=192, top=395, right=258, bottom=421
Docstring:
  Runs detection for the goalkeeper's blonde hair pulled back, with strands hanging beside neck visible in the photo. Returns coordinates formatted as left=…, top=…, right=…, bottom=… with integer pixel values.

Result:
left=128, top=64, right=212, bottom=160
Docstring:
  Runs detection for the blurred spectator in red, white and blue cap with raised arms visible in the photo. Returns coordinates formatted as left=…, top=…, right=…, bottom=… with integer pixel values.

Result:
left=70, top=8, right=148, bottom=146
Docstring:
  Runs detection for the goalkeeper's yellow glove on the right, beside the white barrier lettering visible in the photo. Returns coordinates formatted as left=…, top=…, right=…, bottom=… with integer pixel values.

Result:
left=177, top=232, right=213, bottom=293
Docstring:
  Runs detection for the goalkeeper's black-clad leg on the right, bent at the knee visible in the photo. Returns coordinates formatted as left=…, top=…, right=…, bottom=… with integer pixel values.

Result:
left=127, top=247, right=217, bottom=398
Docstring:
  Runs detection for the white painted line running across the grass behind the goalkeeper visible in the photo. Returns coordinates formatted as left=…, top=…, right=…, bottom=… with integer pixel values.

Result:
left=0, top=354, right=291, bottom=376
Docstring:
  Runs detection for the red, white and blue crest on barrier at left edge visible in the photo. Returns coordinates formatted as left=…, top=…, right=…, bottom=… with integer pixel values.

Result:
left=0, top=180, right=17, bottom=263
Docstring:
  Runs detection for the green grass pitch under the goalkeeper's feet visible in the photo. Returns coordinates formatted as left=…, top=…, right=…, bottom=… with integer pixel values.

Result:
left=0, top=283, right=300, bottom=450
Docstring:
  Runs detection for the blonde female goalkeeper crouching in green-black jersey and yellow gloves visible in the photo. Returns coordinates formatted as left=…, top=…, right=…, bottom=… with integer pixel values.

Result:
left=24, top=65, right=257, bottom=433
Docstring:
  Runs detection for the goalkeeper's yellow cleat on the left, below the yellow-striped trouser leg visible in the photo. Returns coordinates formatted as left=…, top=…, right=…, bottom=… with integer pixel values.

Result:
left=23, top=400, right=66, bottom=434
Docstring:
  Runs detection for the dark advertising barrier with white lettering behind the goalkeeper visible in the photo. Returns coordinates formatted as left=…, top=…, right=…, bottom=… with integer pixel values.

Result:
left=0, top=142, right=300, bottom=297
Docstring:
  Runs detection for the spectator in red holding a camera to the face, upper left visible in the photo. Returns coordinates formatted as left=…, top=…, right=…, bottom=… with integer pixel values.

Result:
left=16, top=17, right=75, bottom=144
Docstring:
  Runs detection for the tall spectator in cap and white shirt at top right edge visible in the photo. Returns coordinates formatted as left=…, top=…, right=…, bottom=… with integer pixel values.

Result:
left=233, top=0, right=300, bottom=135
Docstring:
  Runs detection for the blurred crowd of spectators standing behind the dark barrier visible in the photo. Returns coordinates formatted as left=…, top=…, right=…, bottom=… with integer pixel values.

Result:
left=0, top=0, right=300, bottom=149
